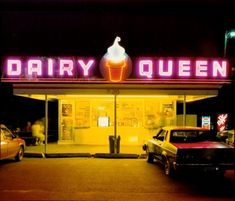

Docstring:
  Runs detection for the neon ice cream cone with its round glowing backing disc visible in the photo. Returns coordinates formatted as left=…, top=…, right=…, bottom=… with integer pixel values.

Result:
left=100, top=37, right=131, bottom=82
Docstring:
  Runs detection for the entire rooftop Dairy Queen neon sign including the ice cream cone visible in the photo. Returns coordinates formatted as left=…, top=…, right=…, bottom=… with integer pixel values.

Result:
left=0, top=37, right=229, bottom=82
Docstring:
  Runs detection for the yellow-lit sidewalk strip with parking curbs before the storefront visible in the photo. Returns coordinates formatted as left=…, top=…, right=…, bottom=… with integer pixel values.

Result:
left=24, top=143, right=145, bottom=158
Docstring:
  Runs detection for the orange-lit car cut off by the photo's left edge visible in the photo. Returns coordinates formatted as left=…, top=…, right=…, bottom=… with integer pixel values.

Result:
left=0, top=124, right=25, bottom=161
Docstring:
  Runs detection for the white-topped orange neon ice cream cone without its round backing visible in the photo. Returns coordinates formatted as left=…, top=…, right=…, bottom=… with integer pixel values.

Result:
left=105, top=37, right=127, bottom=82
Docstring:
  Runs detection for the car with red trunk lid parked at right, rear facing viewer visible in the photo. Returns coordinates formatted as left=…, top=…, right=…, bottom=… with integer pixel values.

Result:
left=143, top=126, right=235, bottom=176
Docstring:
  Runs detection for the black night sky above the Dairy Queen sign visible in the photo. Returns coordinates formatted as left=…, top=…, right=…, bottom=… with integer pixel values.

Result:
left=0, top=0, right=235, bottom=57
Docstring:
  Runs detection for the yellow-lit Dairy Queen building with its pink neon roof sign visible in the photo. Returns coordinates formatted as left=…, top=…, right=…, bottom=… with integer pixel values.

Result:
left=2, top=37, right=229, bottom=152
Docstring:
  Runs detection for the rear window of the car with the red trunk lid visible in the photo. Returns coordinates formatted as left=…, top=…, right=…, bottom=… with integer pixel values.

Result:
left=170, top=130, right=219, bottom=142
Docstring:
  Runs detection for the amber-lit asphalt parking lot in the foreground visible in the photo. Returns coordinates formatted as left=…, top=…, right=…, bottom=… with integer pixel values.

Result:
left=0, top=158, right=235, bottom=201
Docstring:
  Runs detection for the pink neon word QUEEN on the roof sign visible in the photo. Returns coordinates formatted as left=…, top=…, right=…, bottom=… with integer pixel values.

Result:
left=137, top=58, right=228, bottom=78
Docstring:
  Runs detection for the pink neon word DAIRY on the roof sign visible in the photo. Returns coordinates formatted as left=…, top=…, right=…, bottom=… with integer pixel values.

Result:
left=6, top=58, right=95, bottom=78
